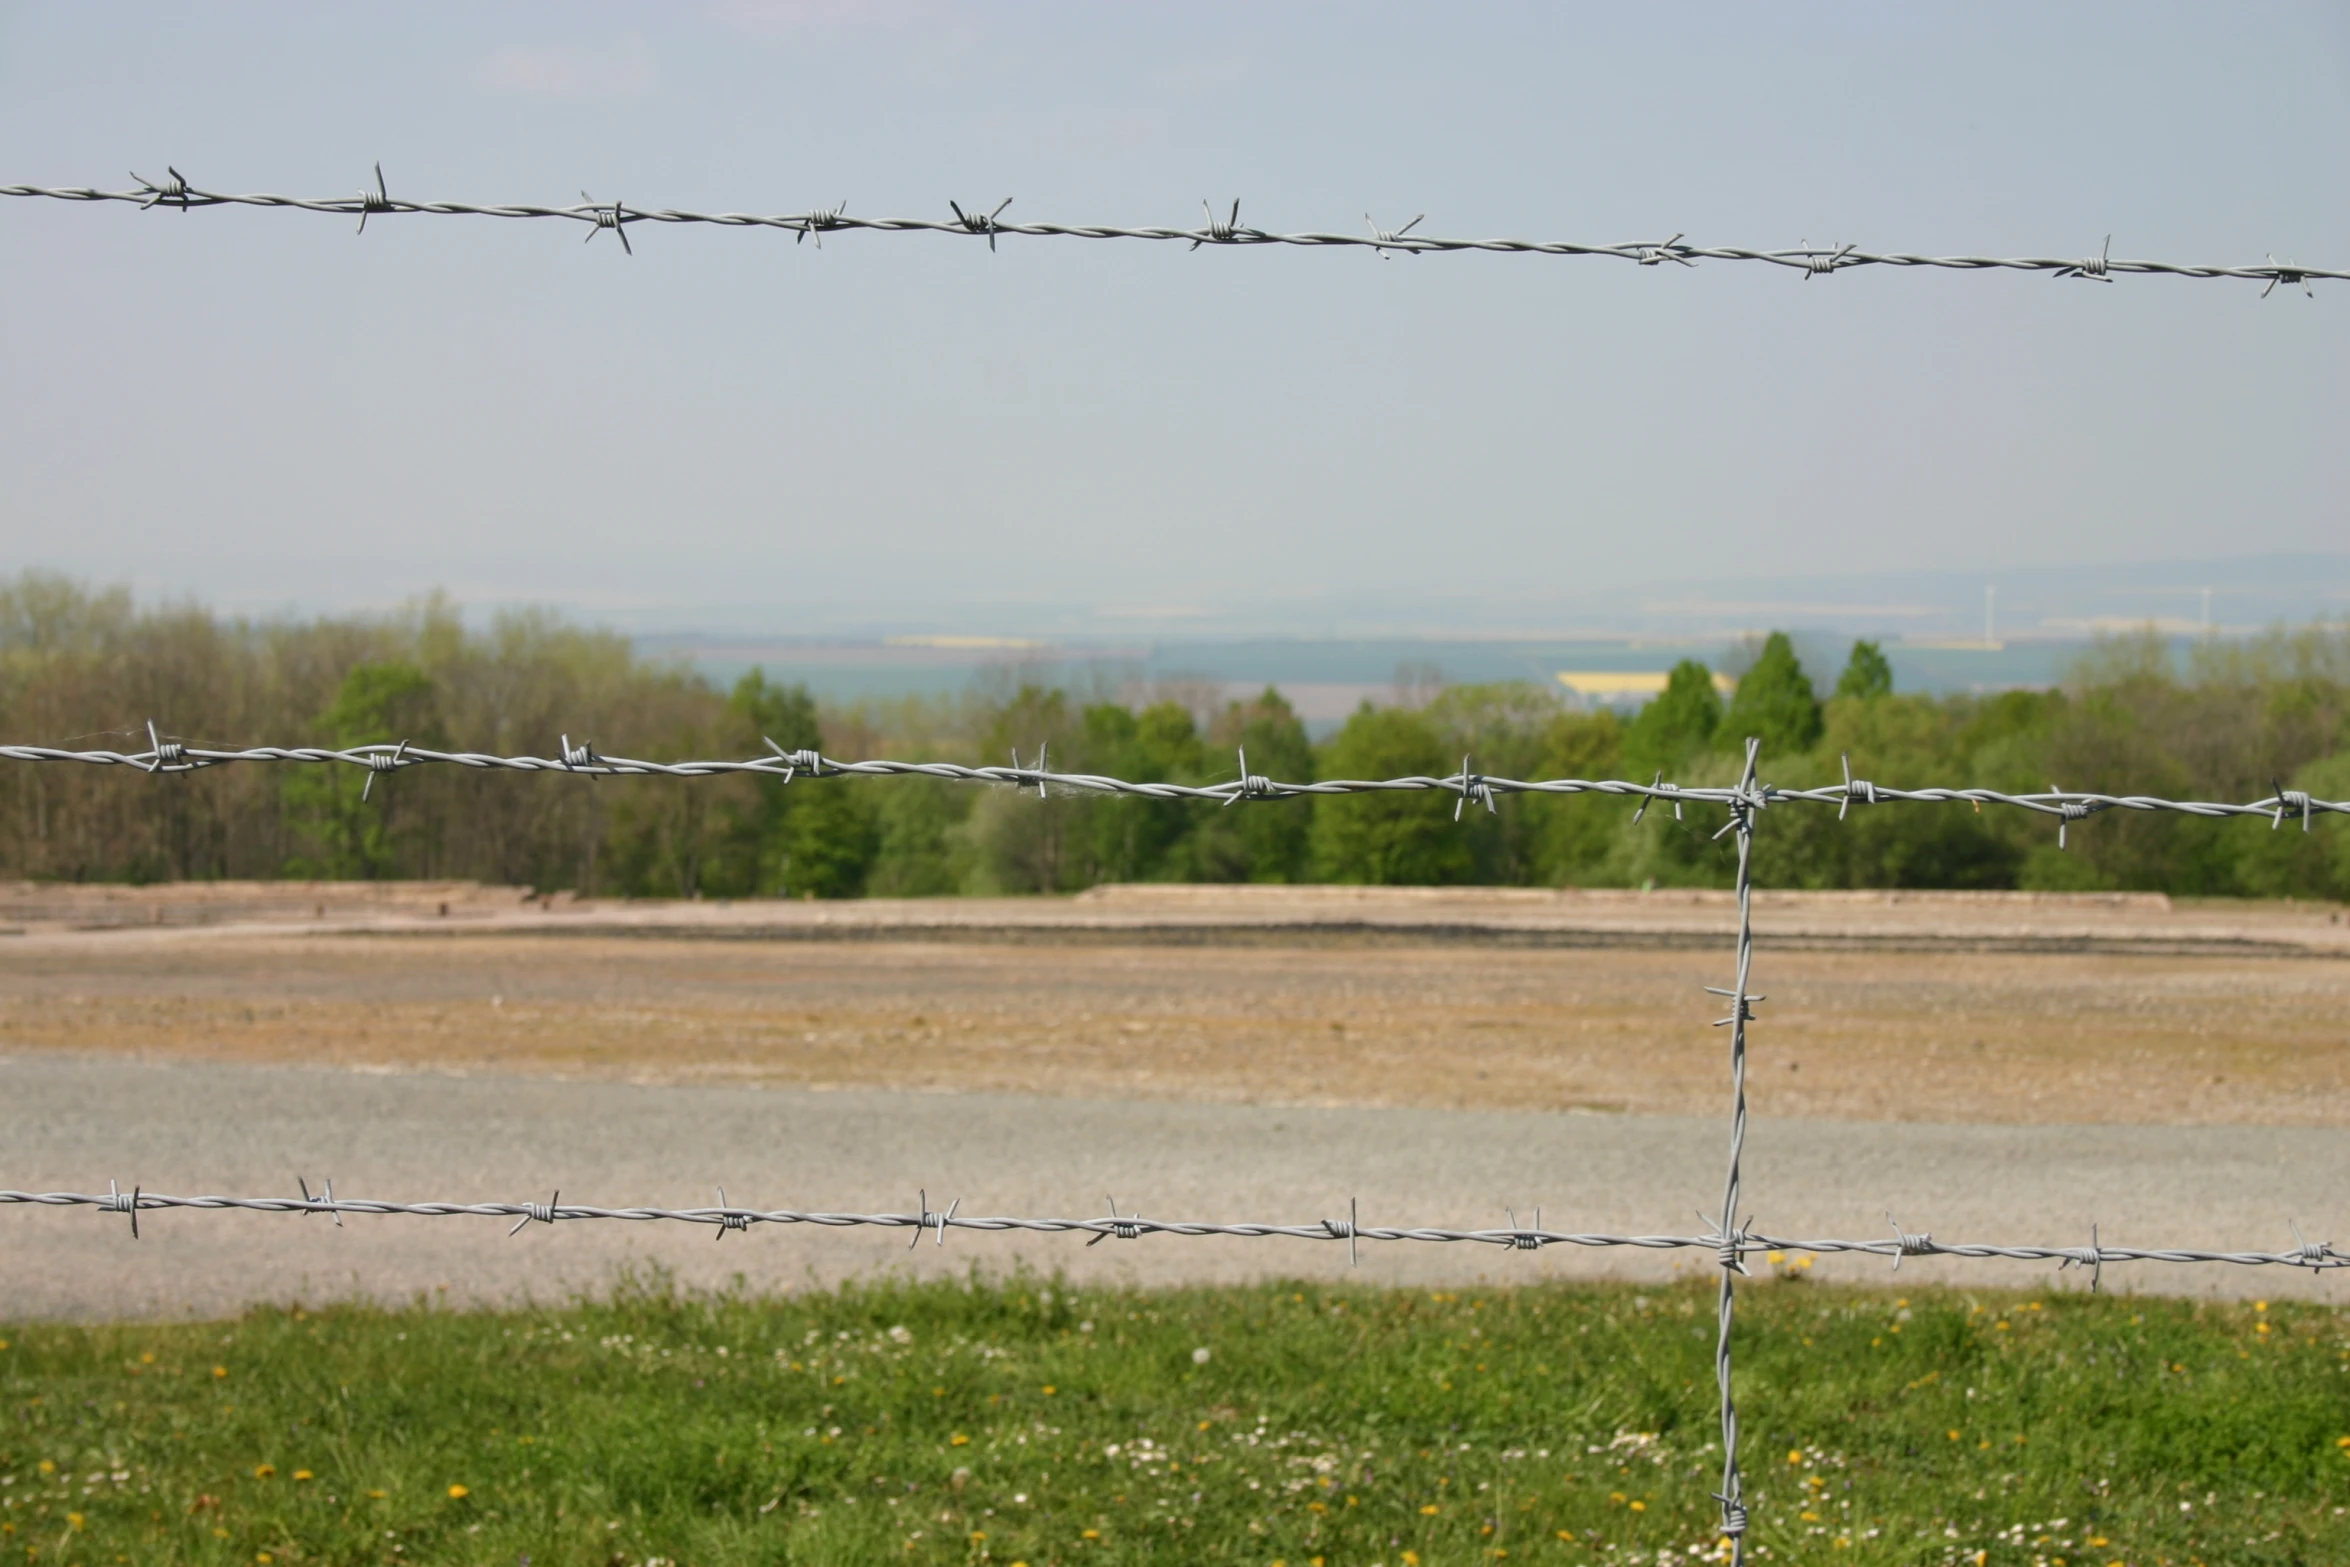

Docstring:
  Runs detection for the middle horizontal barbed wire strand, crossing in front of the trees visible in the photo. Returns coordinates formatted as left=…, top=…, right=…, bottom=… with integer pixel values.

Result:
left=0, top=738, right=2350, bottom=825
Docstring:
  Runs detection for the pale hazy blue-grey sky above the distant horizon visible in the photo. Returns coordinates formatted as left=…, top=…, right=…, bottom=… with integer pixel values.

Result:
left=0, top=0, right=2350, bottom=632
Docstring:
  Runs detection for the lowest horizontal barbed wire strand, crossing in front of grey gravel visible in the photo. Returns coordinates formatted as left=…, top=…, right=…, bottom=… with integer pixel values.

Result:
left=0, top=1189, right=2350, bottom=1271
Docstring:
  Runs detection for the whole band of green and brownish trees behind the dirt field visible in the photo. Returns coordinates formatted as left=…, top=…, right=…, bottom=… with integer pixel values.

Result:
left=0, top=573, right=2350, bottom=897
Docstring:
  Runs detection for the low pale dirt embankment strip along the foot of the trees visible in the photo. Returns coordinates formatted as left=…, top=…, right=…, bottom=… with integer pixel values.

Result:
left=0, top=881, right=2350, bottom=959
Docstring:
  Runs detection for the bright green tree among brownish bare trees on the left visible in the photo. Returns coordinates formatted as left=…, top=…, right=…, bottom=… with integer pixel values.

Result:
left=282, top=660, right=439, bottom=881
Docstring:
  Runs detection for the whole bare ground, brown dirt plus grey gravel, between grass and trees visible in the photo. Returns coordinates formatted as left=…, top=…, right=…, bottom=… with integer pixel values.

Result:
left=0, top=888, right=2350, bottom=1318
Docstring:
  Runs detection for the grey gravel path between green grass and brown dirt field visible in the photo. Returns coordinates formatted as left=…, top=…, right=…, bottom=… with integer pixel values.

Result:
left=0, top=1052, right=2350, bottom=1320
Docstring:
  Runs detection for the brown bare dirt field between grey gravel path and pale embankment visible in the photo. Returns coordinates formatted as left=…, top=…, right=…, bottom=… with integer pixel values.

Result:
left=0, top=895, right=2350, bottom=1125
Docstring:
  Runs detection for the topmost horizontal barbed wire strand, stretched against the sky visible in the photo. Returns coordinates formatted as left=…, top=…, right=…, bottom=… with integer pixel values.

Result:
left=0, top=162, right=2350, bottom=298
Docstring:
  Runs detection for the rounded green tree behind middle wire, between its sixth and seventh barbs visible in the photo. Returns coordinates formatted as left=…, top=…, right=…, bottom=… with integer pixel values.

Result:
left=1314, top=702, right=1473, bottom=886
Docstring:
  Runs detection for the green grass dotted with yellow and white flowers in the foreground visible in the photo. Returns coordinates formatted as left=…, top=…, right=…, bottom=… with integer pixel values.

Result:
left=0, top=1278, right=2350, bottom=1567
